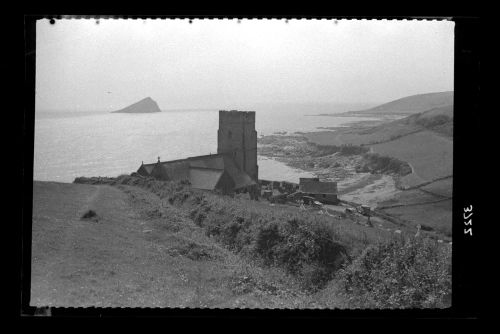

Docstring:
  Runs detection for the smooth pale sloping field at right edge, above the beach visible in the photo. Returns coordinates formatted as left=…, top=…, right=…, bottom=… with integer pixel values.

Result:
left=371, top=131, right=453, bottom=186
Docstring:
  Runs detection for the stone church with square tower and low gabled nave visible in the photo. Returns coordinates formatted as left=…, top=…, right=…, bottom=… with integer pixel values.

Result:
left=137, top=110, right=259, bottom=194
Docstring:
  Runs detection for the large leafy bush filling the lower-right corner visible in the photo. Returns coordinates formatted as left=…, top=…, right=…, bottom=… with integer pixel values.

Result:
left=337, top=238, right=451, bottom=308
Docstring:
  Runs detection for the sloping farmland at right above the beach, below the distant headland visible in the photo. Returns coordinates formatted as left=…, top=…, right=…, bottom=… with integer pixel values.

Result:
left=304, top=105, right=453, bottom=187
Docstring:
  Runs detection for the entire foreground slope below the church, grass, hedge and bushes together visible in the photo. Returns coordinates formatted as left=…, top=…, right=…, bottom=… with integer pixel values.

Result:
left=31, top=176, right=450, bottom=308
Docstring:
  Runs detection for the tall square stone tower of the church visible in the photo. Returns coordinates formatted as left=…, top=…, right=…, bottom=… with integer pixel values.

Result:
left=217, top=110, right=259, bottom=182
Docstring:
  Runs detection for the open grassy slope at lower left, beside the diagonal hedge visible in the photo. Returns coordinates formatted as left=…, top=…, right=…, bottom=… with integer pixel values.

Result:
left=30, top=182, right=303, bottom=307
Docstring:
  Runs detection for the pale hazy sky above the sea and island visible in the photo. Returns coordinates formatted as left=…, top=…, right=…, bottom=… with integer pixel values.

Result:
left=35, top=19, right=454, bottom=111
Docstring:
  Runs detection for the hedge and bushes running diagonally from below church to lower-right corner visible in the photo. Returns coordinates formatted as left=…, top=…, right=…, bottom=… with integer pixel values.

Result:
left=75, top=176, right=451, bottom=308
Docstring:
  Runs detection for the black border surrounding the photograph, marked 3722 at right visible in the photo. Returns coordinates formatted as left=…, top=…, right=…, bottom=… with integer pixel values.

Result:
left=20, top=14, right=482, bottom=319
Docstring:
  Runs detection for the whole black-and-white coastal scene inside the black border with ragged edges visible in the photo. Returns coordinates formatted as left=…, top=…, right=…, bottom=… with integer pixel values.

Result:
left=24, top=17, right=474, bottom=310
